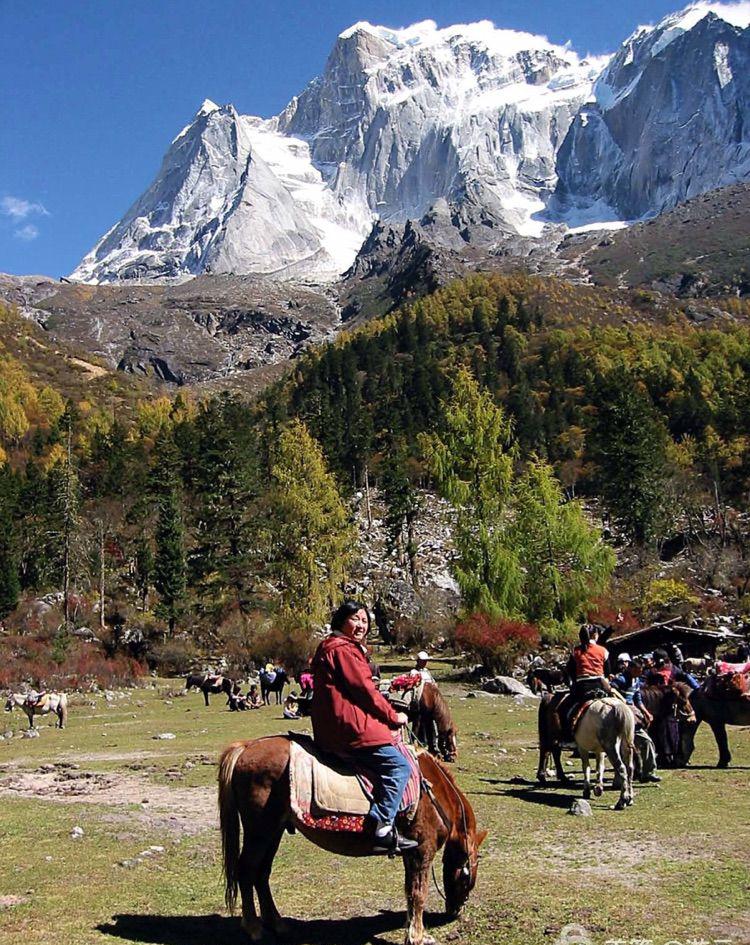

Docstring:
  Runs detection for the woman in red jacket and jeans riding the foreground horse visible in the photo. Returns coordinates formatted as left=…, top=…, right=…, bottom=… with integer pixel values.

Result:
left=310, top=601, right=417, bottom=853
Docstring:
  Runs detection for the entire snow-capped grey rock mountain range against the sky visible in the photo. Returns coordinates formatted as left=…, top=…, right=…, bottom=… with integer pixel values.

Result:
left=73, top=3, right=750, bottom=282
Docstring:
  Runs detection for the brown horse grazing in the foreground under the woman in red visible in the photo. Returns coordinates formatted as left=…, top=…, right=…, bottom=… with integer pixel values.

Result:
left=219, top=735, right=486, bottom=945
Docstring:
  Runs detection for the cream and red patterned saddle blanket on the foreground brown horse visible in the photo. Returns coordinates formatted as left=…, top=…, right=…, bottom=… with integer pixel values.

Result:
left=289, top=734, right=420, bottom=833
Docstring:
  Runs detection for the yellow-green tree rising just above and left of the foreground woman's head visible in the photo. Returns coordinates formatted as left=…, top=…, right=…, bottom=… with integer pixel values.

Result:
left=267, top=420, right=356, bottom=624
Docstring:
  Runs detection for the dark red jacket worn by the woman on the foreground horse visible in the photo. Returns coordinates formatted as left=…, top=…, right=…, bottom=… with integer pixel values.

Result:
left=310, top=634, right=406, bottom=754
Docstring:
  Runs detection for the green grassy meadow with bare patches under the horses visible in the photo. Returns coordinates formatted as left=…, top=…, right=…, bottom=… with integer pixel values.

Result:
left=0, top=664, right=750, bottom=945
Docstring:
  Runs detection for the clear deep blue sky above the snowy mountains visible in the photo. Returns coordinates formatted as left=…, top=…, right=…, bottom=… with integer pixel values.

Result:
left=0, top=0, right=684, bottom=276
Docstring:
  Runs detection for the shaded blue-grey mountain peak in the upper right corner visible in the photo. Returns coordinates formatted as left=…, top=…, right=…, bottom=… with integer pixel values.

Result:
left=552, top=3, right=750, bottom=222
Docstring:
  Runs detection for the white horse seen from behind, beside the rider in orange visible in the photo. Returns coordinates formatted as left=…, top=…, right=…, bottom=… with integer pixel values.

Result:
left=575, top=696, right=635, bottom=810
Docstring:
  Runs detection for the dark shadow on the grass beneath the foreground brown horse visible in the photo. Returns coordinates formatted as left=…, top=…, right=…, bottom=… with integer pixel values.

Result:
left=96, top=909, right=449, bottom=945
